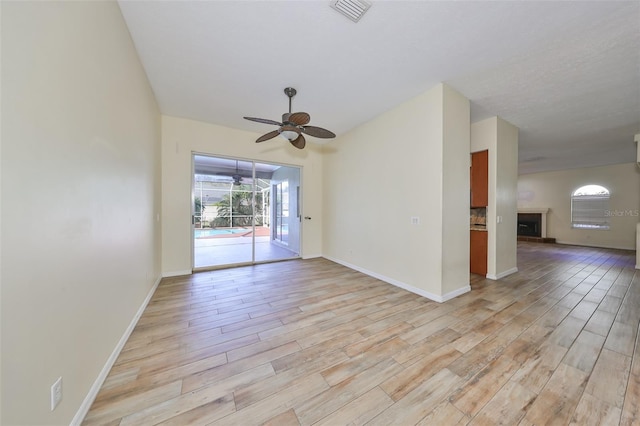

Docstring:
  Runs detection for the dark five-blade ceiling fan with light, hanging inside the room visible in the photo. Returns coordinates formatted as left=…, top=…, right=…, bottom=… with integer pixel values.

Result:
left=244, top=87, right=336, bottom=149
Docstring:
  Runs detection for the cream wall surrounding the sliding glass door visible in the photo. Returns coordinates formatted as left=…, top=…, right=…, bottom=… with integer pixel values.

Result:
left=162, top=116, right=322, bottom=276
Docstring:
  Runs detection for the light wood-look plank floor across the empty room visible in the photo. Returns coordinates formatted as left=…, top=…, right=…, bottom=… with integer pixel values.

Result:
left=84, top=243, right=640, bottom=425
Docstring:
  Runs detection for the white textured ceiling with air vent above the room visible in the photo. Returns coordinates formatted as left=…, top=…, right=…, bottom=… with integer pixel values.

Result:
left=119, top=0, right=640, bottom=173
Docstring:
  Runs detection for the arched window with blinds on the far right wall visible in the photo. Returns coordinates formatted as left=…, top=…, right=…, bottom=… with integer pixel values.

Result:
left=571, top=185, right=609, bottom=229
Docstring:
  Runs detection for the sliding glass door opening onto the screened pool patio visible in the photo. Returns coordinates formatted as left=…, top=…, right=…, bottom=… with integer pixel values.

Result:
left=192, top=154, right=301, bottom=270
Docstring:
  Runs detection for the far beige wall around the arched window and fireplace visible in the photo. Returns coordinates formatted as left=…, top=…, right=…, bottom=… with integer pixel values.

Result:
left=518, top=163, right=640, bottom=250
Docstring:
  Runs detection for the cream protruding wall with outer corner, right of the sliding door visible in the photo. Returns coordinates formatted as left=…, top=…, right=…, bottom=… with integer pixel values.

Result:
left=323, top=84, right=469, bottom=300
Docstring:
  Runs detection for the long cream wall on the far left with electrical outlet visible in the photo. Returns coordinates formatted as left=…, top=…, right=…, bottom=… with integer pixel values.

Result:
left=0, top=1, right=160, bottom=425
